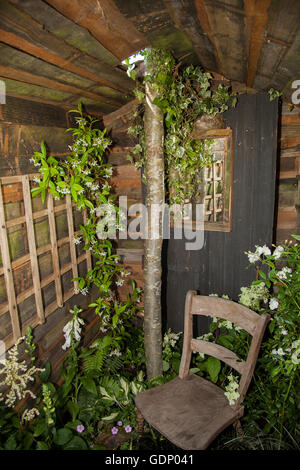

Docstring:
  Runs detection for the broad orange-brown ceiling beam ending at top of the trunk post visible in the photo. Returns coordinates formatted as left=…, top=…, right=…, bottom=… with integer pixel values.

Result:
left=46, top=0, right=148, bottom=60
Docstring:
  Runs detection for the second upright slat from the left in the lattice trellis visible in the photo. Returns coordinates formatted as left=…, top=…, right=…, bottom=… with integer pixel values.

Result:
left=22, top=175, right=45, bottom=323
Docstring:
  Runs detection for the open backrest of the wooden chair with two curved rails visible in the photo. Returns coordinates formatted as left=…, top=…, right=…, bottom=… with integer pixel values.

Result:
left=179, top=290, right=270, bottom=408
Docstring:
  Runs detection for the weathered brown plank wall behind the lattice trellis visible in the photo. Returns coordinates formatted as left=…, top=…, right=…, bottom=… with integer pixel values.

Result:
left=0, top=96, right=99, bottom=380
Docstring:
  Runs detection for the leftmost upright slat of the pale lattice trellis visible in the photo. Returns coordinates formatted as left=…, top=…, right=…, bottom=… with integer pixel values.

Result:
left=0, top=183, right=21, bottom=341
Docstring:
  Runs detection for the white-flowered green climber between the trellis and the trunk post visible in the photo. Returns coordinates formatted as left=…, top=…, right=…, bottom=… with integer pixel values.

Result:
left=32, top=104, right=141, bottom=337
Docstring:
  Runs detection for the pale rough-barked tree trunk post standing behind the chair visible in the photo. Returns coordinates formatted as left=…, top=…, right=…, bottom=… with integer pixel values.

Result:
left=144, top=83, right=165, bottom=379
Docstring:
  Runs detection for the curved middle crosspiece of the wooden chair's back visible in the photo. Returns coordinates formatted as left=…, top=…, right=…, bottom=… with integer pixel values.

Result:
left=191, top=339, right=245, bottom=374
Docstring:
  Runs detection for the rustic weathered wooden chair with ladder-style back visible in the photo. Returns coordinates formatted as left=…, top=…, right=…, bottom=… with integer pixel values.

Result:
left=135, top=291, right=270, bottom=450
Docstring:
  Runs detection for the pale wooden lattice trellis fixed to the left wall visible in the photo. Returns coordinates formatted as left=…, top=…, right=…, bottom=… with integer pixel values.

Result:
left=0, top=174, right=92, bottom=348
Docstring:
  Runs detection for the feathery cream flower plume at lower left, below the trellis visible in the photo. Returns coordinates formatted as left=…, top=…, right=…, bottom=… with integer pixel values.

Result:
left=0, top=336, right=44, bottom=408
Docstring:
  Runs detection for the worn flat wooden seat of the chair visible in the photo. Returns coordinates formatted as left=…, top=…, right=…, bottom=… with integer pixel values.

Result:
left=135, top=374, right=244, bottom=450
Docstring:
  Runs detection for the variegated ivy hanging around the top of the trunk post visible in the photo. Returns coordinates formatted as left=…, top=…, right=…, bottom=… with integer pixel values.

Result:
left=126, top=49, right=237, bottom=204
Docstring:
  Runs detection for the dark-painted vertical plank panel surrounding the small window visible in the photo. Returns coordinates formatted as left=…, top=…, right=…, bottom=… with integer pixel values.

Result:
left=163, top=94, right=278, bottom=332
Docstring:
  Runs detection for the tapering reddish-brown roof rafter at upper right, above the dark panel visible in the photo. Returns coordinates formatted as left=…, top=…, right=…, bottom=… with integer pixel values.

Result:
left=244, top=0, right=271, bottom=87
